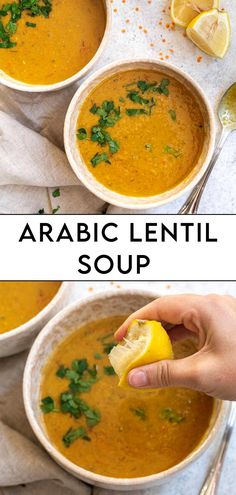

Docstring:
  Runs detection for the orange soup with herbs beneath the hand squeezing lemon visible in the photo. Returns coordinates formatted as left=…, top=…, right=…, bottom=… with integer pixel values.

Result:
left=41, top=316, right=214, bottom=478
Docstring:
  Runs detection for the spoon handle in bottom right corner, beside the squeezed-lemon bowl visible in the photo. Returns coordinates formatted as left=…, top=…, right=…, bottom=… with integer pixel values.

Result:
left=199, top=404, right=236, bottom=495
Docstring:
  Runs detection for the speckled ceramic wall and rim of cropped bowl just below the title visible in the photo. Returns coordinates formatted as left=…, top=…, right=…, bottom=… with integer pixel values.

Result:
left=0, top=282, right=73, bottom=358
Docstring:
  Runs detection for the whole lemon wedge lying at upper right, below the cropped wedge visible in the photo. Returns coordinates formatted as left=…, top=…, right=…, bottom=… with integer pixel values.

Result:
left=186, top=9, right=230, bottom=58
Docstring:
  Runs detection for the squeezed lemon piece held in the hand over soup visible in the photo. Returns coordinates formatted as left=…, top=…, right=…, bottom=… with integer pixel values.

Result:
left=109, top=320, right=174, bottom=387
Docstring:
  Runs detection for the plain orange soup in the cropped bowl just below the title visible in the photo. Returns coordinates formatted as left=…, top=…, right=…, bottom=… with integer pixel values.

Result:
left=0, top=282, right=61, bottom=334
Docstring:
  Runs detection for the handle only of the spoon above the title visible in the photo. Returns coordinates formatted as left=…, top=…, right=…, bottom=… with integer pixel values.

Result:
left=178, top=127, right=230, bottom=215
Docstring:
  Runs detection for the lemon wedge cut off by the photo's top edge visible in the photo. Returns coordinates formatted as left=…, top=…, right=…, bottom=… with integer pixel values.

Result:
left=170, top=0, right=219, bottom=27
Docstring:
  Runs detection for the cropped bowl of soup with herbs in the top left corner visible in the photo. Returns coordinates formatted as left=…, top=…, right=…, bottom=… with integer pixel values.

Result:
left=0, top=0, right=111, bottom=92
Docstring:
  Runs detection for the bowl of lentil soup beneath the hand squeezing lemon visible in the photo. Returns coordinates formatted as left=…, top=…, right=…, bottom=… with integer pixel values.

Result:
left=24, top=290, right=228, bottom=490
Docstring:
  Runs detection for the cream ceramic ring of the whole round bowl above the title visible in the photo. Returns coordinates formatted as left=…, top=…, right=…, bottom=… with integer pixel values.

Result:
left=64, top=59, right=215, bottom=210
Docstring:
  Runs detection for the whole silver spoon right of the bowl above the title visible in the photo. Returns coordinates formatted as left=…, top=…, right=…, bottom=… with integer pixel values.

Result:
left=179, top=83, right=236, bottom=215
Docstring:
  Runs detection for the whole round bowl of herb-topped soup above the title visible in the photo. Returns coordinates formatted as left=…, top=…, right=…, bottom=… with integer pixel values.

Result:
left=65, top=61, right=215, bottom=209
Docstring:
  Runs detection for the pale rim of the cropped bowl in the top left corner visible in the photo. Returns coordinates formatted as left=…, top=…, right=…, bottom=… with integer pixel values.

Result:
left=0, top=0, right=112, bottom=93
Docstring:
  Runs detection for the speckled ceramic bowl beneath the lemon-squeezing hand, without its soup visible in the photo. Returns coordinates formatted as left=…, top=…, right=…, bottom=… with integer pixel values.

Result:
left=23, top=290, right=230, bottom=491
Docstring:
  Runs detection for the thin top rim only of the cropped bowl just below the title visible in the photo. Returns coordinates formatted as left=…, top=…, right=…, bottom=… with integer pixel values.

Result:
left=0, top=280, right=70, bottom=345
